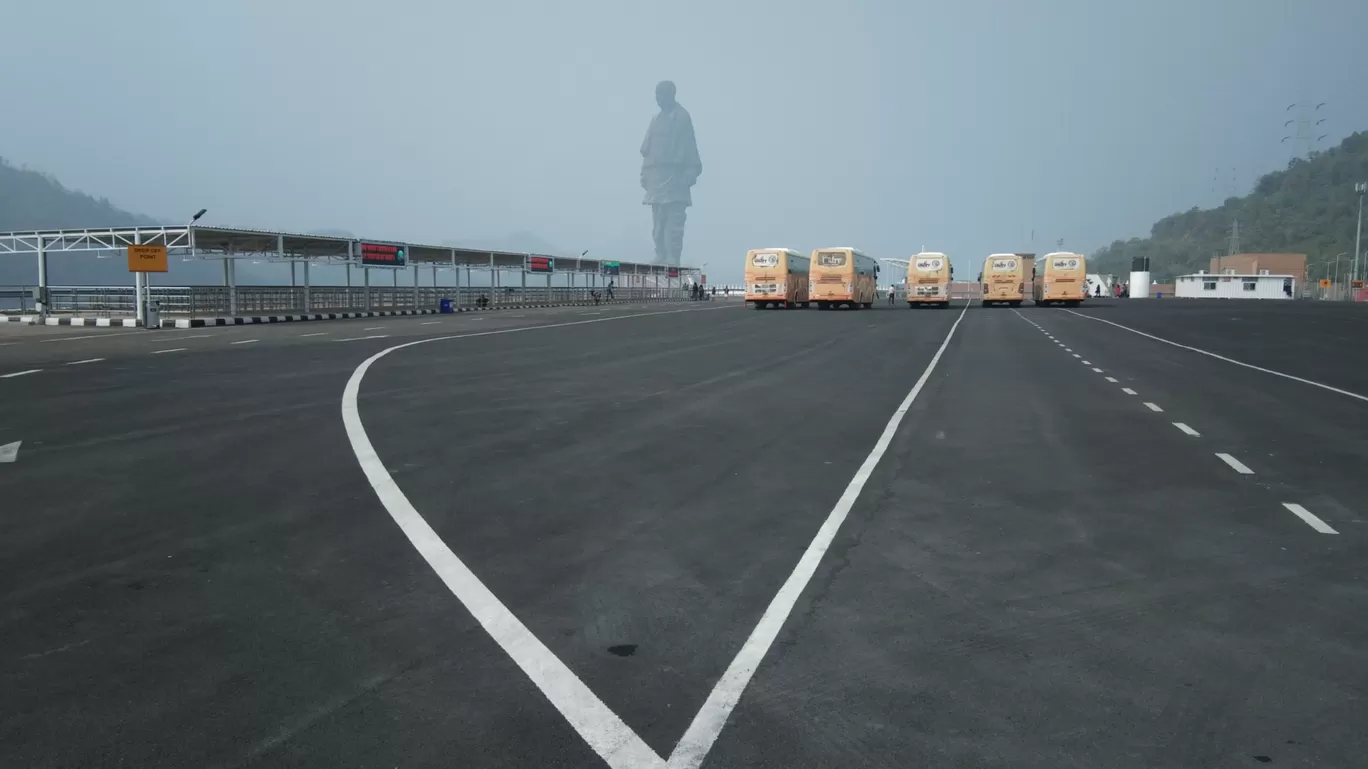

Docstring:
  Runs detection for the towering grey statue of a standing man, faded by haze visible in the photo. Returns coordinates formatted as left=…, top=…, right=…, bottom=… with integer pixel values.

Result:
left=642, top=81, right=703, bottom=265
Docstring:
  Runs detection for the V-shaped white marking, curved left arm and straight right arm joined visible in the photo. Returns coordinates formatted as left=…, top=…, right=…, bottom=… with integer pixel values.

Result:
left=342, top=302, right=969, bottom=769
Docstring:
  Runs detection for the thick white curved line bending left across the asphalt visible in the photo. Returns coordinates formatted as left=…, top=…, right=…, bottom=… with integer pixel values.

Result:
left=342, top=308, right=738, bottom=769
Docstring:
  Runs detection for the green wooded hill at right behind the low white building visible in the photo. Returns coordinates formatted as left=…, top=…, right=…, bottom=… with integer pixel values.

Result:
left=1090, top=131, right=1368, bottom=282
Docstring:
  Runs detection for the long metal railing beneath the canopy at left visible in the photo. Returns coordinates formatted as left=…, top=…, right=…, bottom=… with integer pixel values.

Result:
left=0, top=286, right=687, bottom=317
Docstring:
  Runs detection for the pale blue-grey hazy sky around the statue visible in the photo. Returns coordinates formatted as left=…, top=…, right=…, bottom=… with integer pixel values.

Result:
left=0, top=0, right=1368, bottom=282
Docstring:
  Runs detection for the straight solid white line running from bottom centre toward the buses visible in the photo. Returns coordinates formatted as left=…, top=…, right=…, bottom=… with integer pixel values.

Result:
left=669, top=302, right=969, bottom=769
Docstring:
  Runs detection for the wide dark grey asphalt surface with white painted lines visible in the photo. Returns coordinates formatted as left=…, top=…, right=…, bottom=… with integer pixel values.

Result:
left=0, top=300, right=1368, bottom=769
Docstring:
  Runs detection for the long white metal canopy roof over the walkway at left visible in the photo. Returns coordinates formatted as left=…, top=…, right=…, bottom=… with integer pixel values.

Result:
left=0, top=224, right=684, bottom=278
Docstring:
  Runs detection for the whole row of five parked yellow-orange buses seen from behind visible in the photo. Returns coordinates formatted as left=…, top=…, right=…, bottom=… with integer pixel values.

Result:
left=746, top=248, right=1088, bottom=309
